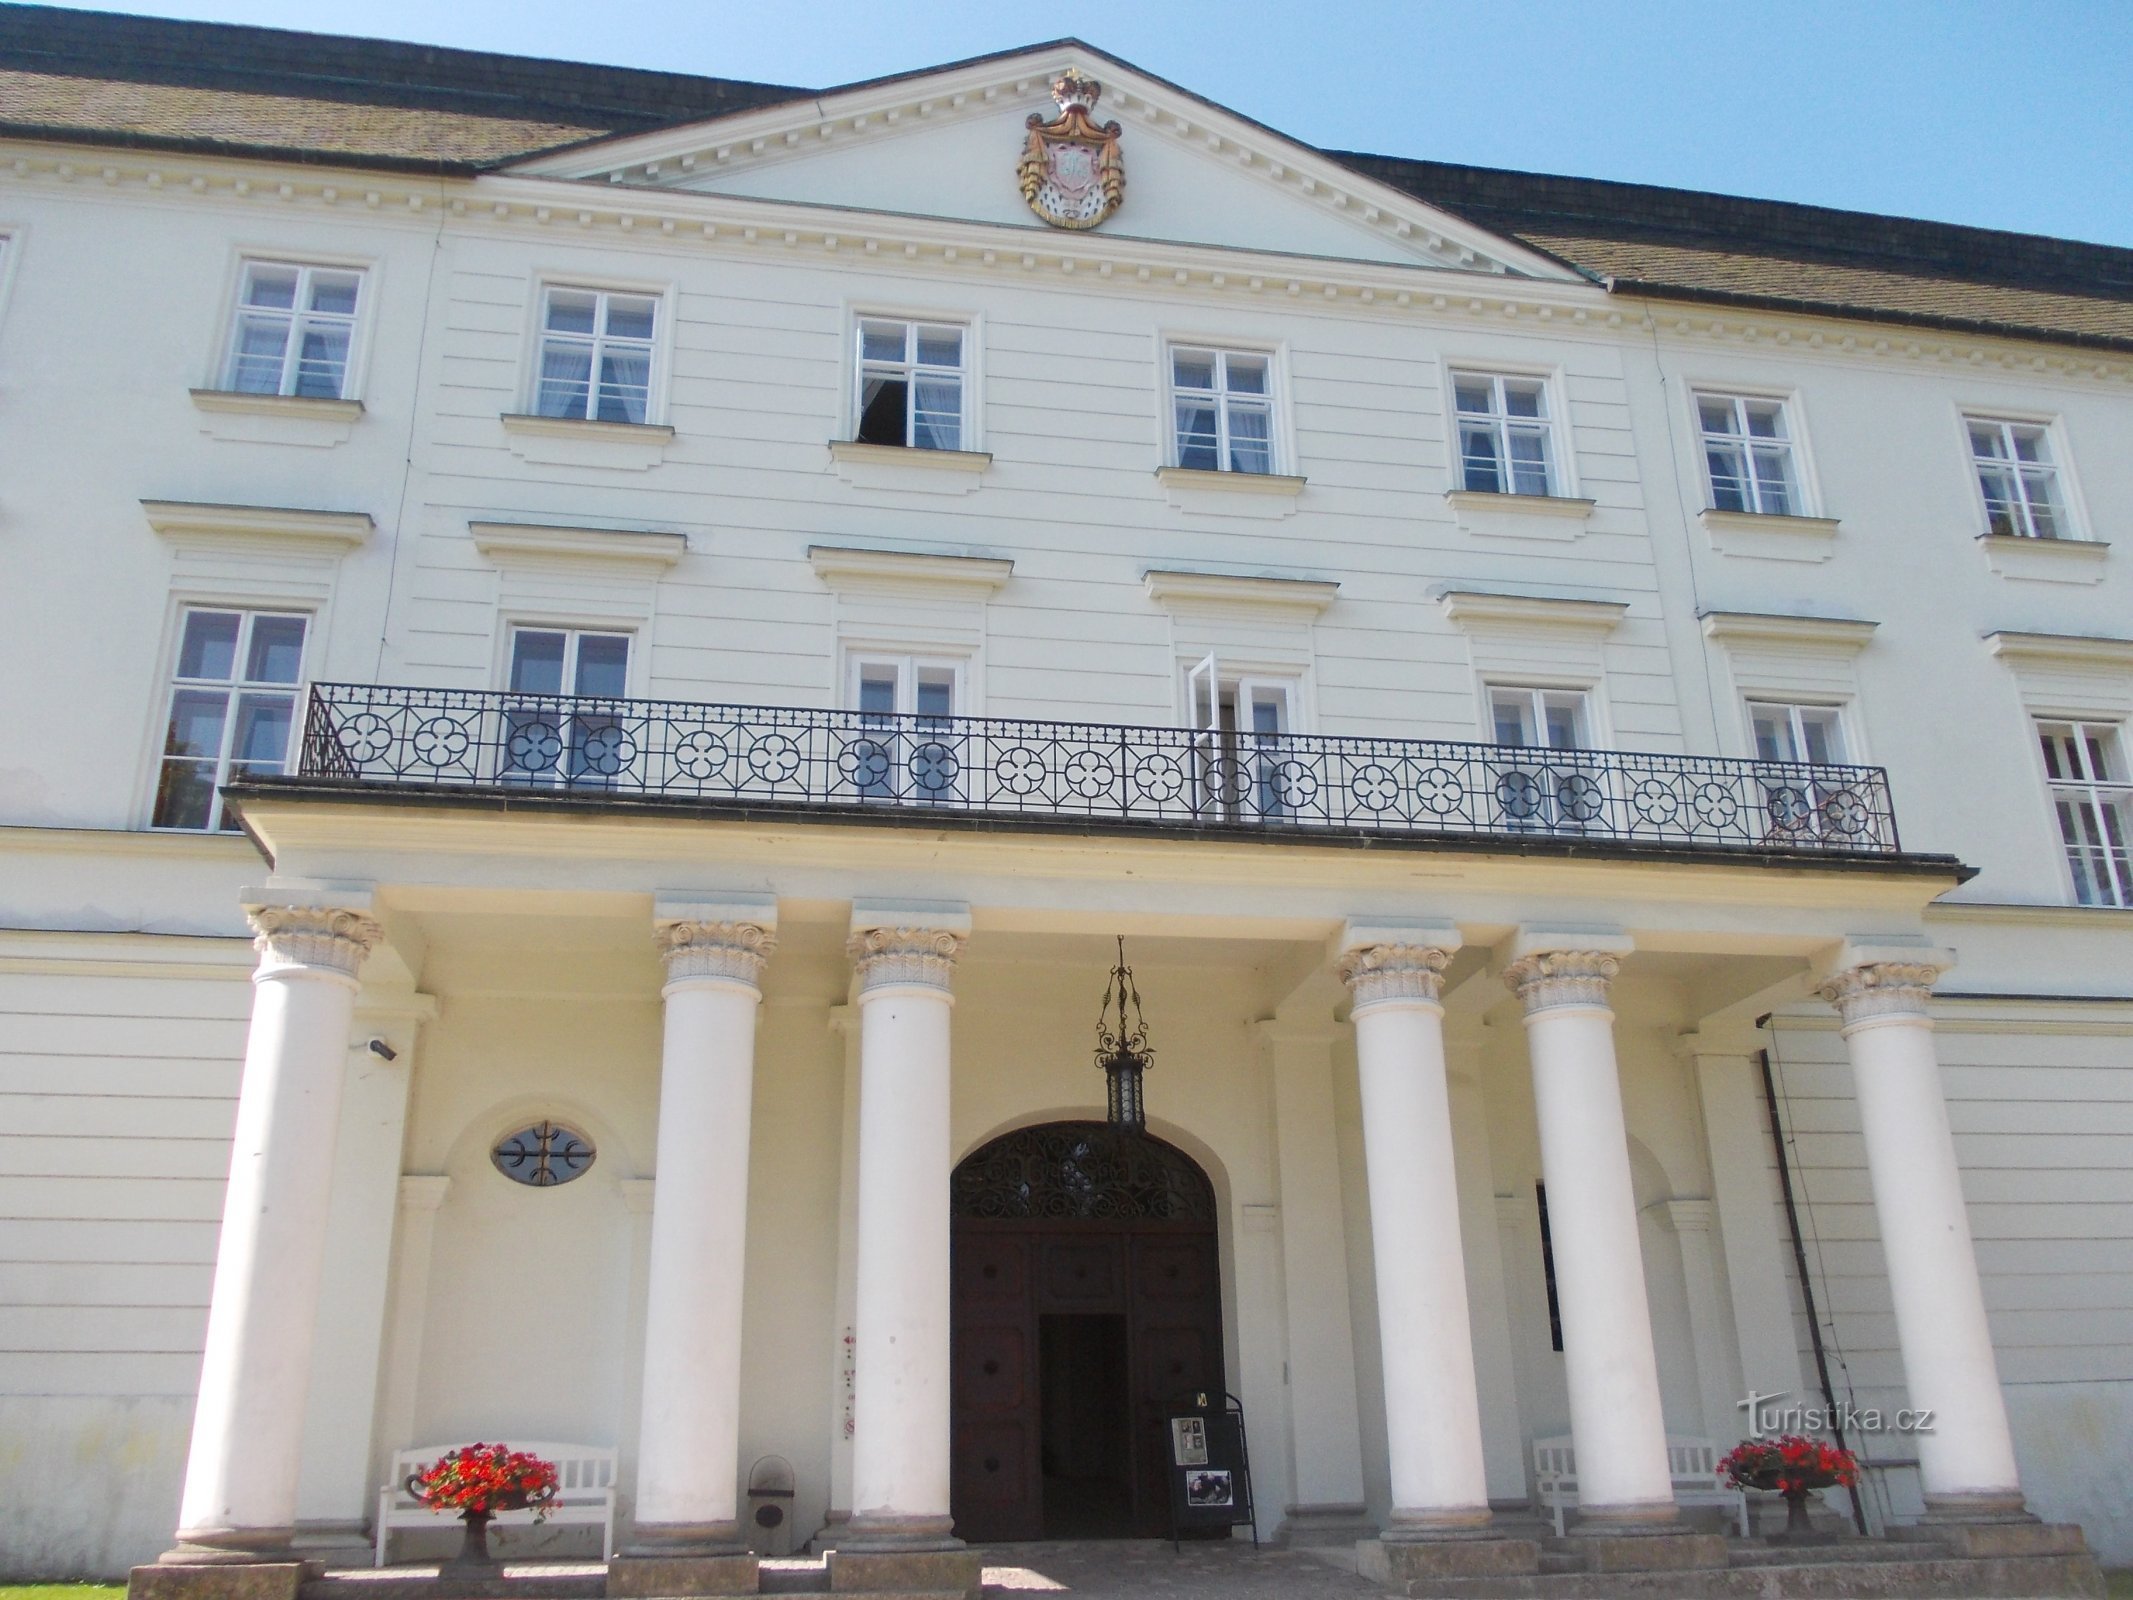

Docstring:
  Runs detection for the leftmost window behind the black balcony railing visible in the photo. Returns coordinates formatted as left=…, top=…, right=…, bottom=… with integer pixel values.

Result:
left=501, top=627, right=636, bottom=789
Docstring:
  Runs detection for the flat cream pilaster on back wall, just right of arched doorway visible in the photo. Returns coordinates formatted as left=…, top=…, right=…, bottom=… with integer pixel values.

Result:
left=1254, top=1009, right=1365, bottom=1538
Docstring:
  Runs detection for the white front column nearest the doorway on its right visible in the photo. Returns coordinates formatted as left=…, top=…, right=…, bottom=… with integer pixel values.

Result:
left=1340, top=928, right=1489, bottom=1540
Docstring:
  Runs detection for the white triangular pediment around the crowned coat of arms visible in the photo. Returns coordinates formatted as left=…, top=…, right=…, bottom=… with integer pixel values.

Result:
left=510, top=41, right=1576, bottom=279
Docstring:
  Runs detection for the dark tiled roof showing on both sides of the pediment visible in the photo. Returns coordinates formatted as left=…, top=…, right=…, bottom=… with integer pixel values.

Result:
left=0, top=4, right=2133, bottom=350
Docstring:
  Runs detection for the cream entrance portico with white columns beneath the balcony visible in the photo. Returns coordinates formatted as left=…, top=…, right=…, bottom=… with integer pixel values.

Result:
left=116, top=750, right=2081, bottom=1594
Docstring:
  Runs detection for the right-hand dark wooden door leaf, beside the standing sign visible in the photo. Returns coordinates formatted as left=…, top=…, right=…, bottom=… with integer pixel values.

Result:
left=1128, top=1233, right=1222, bottom=1538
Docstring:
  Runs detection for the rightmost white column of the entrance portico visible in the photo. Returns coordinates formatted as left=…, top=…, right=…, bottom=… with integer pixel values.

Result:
left=1822, top=947, right=2022, bottom=1519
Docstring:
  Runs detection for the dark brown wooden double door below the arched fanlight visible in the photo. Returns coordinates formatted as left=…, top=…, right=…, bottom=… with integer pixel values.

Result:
left=951, top=1218, right=1222, bottom=1540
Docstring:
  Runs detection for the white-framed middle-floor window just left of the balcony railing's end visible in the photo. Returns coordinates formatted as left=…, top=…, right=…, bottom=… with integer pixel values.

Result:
left=151, top=606, right=311, bottom=830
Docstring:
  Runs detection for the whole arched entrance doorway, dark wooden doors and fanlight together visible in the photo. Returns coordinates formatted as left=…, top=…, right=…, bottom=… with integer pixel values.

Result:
left=949, top=1122, right=1222, bottom=1540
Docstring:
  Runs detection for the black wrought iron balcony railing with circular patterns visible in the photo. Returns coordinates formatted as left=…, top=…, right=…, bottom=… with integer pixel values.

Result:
left=296, top=683, right=1898, bottom=855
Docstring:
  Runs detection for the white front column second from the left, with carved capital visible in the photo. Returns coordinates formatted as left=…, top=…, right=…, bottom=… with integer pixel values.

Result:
left=629, top=907, right=776, bottom=1555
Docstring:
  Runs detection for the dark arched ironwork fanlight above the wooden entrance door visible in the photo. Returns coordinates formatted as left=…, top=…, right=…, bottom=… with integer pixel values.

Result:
left=949, top=1122, right=1216, bottom=1227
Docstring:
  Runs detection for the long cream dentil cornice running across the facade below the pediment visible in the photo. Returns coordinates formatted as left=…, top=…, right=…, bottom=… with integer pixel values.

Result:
left=0, top=141, right=2133, bottom=384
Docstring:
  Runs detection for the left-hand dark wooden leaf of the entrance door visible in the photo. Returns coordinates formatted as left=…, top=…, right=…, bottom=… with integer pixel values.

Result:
left=949, top=1227, right=1043, bottom=1540
